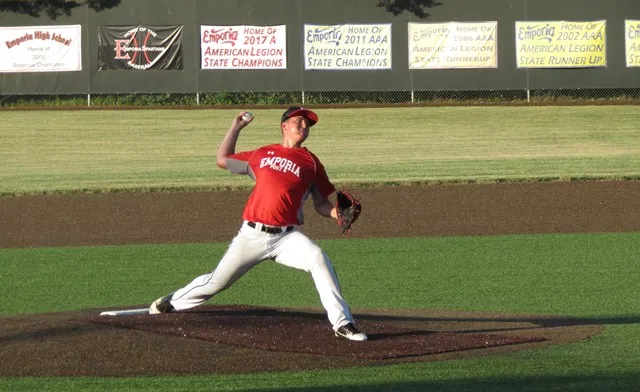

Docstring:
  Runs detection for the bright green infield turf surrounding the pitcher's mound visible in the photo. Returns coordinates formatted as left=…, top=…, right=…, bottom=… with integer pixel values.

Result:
left=0, top=233, right=640, bottom=391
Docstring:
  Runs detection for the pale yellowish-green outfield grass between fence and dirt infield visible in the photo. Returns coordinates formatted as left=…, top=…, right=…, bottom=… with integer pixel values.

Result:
left=0, top=106, right=640, bottom=195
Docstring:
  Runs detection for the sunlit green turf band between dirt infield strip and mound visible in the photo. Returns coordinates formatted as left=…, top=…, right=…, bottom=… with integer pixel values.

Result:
left=0, top=233, right=640, bottom=316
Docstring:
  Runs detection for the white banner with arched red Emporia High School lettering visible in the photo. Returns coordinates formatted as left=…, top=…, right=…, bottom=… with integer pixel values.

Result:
left=0, top=25, right=82, bottom=72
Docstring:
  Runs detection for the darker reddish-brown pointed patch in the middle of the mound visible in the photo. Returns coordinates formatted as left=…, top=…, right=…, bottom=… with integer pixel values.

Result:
left=90, top=306, right=545, bottom=360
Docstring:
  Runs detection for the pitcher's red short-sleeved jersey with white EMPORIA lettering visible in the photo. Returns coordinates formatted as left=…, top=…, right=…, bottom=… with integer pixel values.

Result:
left=227, top=144, right=335, bottom=226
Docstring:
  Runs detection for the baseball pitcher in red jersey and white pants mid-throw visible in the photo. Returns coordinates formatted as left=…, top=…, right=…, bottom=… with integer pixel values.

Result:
left=149, top=106, right=367, bottom=341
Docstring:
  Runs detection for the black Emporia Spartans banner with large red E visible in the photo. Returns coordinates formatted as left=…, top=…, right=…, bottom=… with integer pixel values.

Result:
left=98, top=25, right=183, bottom=71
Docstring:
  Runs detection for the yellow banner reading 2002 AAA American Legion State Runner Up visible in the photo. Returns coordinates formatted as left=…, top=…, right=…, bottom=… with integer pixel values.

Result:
left=516, top=20, right=607, bottom=68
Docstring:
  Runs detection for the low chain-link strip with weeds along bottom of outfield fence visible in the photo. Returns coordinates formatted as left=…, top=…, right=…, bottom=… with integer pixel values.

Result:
left=0, top=88, right=640, bottom=108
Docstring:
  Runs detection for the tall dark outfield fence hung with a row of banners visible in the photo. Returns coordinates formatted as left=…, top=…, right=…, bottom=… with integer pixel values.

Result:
left=0, top=0, right=640, bottom=108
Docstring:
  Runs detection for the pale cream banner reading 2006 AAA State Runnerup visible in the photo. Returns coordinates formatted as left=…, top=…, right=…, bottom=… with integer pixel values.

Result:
left=409, top=22, right=498, bottom=69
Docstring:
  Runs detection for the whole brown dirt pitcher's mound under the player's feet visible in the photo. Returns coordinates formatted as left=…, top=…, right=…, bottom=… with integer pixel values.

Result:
left=0, top=305, right=604, bottom=377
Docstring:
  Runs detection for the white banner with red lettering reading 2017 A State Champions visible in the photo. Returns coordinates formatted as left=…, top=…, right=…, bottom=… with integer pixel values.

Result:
left=200, top=25, right=287, bottom=69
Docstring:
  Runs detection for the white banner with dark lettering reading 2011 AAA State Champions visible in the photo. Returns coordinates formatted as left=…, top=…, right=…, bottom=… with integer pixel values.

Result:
left=304, top=24, right=391, bottom=70
